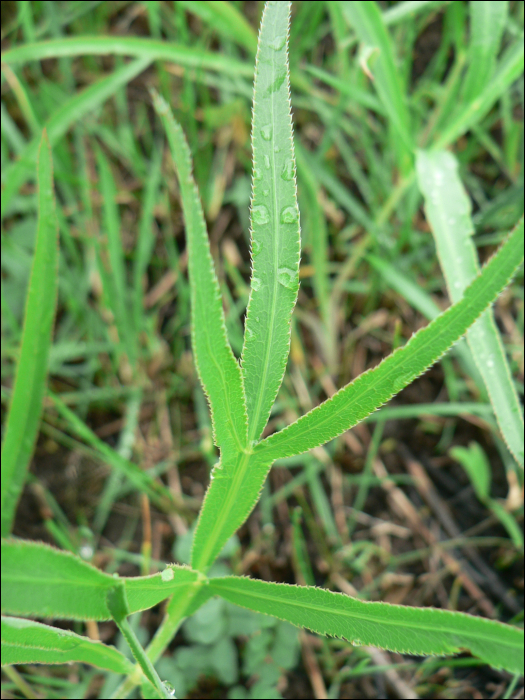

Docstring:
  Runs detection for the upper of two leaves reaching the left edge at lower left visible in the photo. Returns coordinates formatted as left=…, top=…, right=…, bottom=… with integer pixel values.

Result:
left=2, top=539, right=200, bottom=620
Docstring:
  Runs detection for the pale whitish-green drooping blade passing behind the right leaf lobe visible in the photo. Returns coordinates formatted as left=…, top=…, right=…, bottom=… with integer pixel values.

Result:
left=416, top=151, right=524, bottom=467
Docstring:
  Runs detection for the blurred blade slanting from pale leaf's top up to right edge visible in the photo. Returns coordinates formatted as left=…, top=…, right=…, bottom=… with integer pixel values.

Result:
left=432, top=35, right=524, bottom=150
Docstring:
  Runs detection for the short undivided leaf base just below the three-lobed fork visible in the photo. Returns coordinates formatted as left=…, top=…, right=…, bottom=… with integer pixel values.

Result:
left=191, top=452, right=273, bottom=572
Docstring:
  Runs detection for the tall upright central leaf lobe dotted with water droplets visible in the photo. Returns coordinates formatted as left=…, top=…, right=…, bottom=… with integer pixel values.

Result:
left=241, top=2, right=301, bottom=443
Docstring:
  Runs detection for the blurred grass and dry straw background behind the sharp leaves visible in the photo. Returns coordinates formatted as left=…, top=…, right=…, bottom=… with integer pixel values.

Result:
left=1, top=1, right=524, bottom=698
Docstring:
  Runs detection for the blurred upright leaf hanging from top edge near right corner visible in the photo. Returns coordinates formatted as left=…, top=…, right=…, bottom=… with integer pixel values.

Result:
left=462, top=0, right=509, bottom=102
